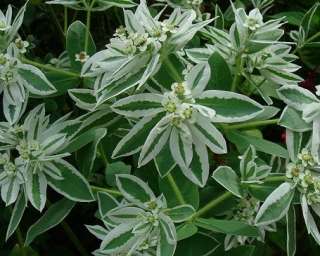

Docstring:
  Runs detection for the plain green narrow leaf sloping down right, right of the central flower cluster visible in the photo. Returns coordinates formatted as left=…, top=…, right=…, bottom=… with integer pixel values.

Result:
left=226, top=131, right=288, bottom=158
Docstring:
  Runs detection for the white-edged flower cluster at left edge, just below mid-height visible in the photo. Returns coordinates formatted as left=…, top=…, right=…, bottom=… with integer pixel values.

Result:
left=0, top=105, right=90, bottom=211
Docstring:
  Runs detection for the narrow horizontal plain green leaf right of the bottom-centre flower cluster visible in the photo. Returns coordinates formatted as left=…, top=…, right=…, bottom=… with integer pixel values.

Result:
left=195, top=218, right=260, bottom=237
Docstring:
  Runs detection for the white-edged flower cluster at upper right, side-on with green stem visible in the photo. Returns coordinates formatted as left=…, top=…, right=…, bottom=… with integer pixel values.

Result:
left=186, top=6, right=302, bottom=101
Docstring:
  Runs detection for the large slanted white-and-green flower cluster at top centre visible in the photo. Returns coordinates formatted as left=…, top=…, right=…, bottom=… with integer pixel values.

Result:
left=78, top=0, right=211, bottom=105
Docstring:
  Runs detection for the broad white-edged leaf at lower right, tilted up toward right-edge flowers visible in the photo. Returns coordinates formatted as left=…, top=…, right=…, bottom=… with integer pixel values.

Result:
left=255, top=182, right=295, bottom=226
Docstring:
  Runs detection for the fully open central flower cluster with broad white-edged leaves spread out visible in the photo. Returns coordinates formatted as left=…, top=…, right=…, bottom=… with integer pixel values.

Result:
left=112, top=64, right=263, bottom=186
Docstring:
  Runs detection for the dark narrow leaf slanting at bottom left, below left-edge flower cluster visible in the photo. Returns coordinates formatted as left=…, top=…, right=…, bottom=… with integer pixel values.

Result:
left=25, top=199, right=76, bottom=245
